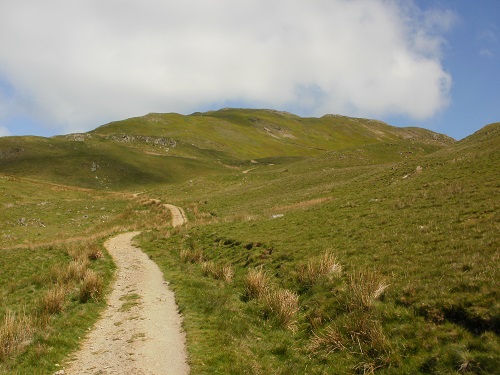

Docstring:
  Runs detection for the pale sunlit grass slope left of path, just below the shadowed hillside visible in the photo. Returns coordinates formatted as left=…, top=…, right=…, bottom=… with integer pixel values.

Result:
left=0, top=175, right=130, bottom=248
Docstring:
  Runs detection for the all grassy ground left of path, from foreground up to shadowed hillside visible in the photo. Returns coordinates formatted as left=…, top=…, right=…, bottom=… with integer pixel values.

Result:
left=0, top=175, right=174, bottom=374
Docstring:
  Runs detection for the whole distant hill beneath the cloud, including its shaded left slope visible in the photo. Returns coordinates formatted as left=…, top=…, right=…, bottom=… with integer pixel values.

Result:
left=0, top=109, right=454, bottom=190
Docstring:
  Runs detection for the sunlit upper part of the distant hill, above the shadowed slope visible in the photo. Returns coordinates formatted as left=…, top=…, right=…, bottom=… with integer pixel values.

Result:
left=91, top=109, right=453, bottom=160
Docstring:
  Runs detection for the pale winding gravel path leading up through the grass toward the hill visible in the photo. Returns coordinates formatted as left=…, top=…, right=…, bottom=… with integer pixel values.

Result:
left=61, top=205, right=189, bottom=375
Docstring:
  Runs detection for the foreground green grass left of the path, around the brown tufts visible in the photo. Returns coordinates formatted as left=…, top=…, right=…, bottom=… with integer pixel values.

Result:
left=0, top=242, right=113, bottom=374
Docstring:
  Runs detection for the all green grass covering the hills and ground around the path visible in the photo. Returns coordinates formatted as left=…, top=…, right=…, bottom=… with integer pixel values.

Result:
left=0, top=110, right=500, bottom=374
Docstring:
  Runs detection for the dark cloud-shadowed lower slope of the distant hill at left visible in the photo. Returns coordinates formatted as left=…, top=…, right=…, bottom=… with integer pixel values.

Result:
left=0, top=137, right=221, bottom=190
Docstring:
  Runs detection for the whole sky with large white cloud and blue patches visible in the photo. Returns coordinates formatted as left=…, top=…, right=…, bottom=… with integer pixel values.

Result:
left=0, top=0, right=500, bottom=139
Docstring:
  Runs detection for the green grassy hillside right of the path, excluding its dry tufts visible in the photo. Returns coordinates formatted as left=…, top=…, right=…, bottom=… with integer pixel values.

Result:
left=138, top=124, right=500, bottom=374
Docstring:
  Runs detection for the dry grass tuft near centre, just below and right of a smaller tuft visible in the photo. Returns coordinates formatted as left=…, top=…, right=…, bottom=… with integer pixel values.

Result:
left=261, top=288, right=299, bottom=331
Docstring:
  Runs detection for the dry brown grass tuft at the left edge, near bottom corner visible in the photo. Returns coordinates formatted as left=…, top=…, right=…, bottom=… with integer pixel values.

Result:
left=0, top=311, right=34, bottom=360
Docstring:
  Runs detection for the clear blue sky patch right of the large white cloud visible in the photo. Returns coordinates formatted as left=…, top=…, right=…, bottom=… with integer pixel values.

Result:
left=394, top=0, right=500, bottom=139
